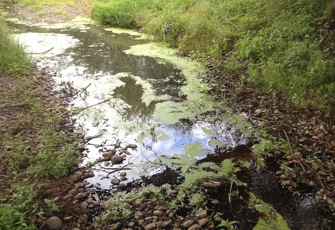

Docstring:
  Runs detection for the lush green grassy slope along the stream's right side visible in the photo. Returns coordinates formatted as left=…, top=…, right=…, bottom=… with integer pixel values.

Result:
left=92, top=0, right=335, bottom=110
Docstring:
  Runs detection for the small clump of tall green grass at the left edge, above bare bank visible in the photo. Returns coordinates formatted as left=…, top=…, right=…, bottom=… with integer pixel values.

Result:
left=0, top=19, right=28, bottom=75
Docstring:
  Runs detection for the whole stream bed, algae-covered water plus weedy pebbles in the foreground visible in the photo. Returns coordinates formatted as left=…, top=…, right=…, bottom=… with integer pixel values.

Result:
left=1, top=4, right=331, bottom=229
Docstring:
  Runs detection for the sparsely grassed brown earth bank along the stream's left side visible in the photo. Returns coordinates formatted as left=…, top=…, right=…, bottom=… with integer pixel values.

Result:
left=0, top=20, right=79, bottom=229
